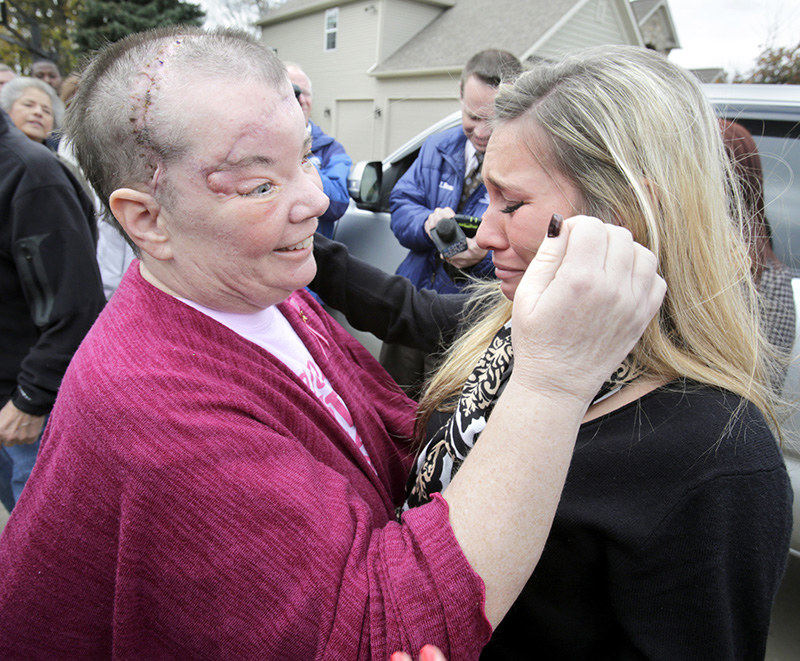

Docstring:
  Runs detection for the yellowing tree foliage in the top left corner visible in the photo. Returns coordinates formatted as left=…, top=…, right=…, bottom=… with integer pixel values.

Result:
left=0, top=0, right=80, bottom=71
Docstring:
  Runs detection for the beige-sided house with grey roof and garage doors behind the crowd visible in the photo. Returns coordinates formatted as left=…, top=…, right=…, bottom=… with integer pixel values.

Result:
left=259, top=0, right=644, bottom=160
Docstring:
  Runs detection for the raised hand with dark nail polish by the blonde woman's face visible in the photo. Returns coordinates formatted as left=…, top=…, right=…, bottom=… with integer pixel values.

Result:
left=512, top=216, right=666, bottom=405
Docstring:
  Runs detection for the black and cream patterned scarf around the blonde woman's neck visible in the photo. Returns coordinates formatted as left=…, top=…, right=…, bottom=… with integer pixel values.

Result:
left=398, top=321, right=630, bottom=514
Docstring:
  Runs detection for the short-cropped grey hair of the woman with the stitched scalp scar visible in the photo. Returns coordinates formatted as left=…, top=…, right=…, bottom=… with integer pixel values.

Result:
left=66, top=26, right=289, bottom=245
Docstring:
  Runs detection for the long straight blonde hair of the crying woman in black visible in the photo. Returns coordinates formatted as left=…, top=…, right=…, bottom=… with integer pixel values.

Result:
left=417, top=46, right=775, bottom=437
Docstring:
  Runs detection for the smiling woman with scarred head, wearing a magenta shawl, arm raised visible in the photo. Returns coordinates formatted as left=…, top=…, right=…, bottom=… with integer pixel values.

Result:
left=0, top=27, right=665, bottom=660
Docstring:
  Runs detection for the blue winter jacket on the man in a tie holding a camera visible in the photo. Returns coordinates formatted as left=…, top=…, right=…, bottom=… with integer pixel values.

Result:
left=389, top=126, right=493, bottom=294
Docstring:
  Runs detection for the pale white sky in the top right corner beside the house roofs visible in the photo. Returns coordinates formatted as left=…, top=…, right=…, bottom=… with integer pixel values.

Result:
left=669, top=0, right=800, bottom=73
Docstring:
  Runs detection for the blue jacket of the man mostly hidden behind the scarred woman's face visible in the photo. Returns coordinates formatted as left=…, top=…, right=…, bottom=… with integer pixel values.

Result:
left=308, top=120, right=353, bottom=238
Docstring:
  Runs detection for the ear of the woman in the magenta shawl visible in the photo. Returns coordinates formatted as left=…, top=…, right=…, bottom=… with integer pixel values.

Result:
left=108, top=188, right=172, bottom=261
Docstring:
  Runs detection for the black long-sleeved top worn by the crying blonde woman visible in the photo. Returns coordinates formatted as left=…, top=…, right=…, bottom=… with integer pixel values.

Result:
left=310, top=237, right=792, bottom=661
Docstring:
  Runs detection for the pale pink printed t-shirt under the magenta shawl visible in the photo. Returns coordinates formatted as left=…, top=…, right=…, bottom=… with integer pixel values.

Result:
left=178, top=297, right=375, bottom=470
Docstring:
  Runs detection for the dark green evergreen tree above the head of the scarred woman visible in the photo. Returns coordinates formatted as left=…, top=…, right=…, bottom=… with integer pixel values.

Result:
left=74, top=0, right=205, bottom=52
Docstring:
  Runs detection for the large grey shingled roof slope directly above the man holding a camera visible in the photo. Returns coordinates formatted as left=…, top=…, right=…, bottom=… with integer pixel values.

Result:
left=370, top=0, right=583, bottom=77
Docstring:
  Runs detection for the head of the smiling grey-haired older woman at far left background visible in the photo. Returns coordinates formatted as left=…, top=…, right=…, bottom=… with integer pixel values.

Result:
left=0, top=76, right=64, bottom=143
